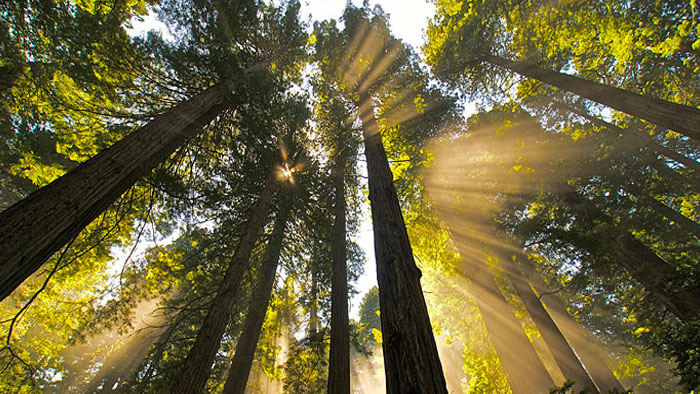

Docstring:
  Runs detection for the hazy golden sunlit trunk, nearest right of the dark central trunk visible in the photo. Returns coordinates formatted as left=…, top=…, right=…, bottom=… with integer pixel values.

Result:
left=441, top=214, right=554, bottom=394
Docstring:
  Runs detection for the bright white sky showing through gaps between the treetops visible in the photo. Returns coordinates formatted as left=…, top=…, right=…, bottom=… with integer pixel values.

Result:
left=130, top=0, right=435, bottom=319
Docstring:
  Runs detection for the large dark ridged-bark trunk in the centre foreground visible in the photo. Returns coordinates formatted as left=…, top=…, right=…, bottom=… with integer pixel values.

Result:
left=359, top=92, right=447, bottom=394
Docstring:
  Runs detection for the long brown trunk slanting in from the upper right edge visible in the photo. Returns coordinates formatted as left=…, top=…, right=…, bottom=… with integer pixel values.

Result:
left=484, top=54, right=700, bottom=141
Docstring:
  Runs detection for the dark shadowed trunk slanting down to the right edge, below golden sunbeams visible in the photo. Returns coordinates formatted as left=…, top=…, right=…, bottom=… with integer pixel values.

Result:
left=559, top=184, right=700, bottom=321
